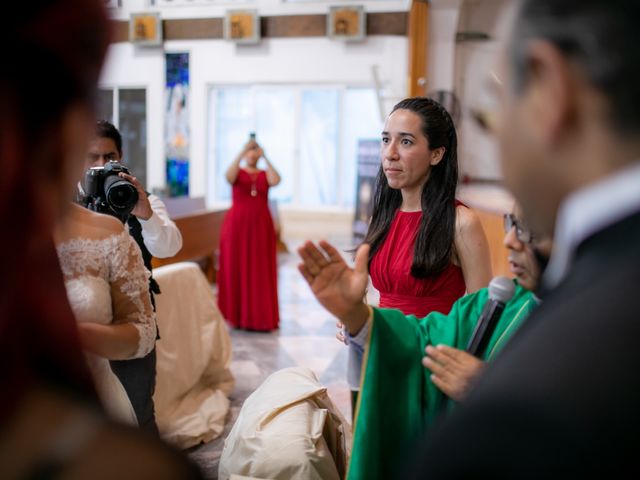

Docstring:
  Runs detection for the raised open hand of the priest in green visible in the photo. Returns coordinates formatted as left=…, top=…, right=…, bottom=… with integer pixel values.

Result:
left=298, top=241, right=369, bottom=333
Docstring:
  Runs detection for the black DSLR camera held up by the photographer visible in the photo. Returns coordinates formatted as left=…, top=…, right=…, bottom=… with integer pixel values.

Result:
left=79, top=162, right=138, bottom=223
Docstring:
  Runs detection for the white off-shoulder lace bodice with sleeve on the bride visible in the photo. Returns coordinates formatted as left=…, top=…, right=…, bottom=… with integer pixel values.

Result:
left=57, top=231, right=156, bottom=358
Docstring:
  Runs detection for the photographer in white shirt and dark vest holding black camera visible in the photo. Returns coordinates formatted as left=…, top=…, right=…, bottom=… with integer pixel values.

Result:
left=80, top=120, right=182, bottom=433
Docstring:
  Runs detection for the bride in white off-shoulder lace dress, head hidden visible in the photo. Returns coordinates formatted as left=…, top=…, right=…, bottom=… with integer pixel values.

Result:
left=55, top=205, right=156, bottom=424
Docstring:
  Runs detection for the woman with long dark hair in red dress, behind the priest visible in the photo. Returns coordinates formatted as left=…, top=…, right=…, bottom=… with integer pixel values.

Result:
left=364, top=97, right=491, bottom=317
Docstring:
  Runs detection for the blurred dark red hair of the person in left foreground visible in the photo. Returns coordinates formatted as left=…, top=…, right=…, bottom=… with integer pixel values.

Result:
left=0, top=0, right=109, bottom=423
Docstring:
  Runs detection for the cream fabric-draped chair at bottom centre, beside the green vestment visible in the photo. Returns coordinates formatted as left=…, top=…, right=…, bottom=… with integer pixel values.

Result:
left=218, top=367, right=349, bottom=480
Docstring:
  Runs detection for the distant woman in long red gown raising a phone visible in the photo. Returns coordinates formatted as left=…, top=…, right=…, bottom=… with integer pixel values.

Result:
left=218, top=138, right=280, bottom=331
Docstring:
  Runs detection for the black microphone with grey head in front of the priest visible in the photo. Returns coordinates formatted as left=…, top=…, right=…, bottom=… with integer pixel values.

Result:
left=467, top=277, right=516, bottom=358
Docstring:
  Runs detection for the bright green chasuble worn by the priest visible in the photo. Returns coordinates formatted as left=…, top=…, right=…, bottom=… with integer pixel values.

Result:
left=348, top=283, right=537, bottom=480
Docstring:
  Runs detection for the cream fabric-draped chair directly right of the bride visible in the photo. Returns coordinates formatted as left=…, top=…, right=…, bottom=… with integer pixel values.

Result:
left=153, top=262, right=234, bottom=448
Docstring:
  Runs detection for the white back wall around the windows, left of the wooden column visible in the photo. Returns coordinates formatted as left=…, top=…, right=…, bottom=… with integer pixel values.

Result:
left=101, top=0, right=408, bottom=201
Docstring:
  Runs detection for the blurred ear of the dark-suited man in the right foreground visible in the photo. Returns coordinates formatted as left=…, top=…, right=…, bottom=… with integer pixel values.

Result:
left=525, top=40, right=576, bottom=144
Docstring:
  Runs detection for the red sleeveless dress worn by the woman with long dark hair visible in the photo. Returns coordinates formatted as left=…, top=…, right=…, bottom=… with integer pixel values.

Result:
left=370, top=210, right=466, bottom=318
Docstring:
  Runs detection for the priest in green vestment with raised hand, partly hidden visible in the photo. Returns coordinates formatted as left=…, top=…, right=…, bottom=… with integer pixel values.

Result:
left=299, top=207, right=550, bottom=480
